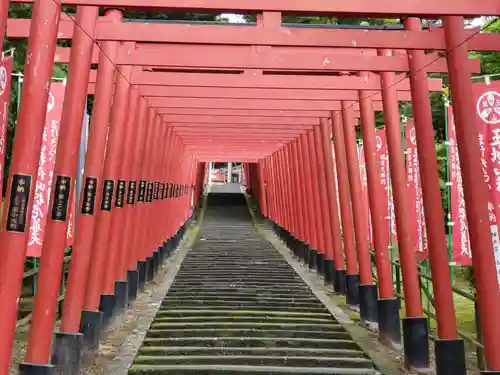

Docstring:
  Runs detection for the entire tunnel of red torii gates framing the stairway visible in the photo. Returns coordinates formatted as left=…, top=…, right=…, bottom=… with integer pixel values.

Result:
left=0, top=0, right=500, bottom=375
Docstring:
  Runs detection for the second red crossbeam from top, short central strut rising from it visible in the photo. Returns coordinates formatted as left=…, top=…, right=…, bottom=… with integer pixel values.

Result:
left=7, top=16, right=500, bottom=52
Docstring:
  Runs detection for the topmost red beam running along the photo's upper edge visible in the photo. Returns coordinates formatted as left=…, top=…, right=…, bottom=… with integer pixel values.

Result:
left=11, top=0, right=500, bottom=17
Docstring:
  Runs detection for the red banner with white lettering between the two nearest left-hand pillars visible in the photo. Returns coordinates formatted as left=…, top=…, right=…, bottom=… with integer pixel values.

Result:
left=26, top=82, right=74, bottom=257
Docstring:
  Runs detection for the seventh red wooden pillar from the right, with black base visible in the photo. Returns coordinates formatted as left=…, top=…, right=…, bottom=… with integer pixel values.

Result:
left=320, top=119, right=345, bottom=294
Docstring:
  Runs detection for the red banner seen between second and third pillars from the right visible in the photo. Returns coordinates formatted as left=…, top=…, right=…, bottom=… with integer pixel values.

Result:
left=405, top=119, right=428, bottom=260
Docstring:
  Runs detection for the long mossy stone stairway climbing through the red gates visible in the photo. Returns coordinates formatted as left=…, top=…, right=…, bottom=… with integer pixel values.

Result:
left=129, top=194, right=377, bottom=375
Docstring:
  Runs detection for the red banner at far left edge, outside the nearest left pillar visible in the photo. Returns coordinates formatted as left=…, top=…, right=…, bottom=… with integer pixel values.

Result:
left=0, top=56, right=12, bottom=197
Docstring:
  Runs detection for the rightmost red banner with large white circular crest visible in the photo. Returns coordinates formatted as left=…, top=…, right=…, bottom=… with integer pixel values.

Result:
left=473, top=81, right=500, bottom=284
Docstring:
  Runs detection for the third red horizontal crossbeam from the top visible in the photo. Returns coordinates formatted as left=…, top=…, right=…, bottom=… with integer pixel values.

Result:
left=55, top=44, right=480, bottom=73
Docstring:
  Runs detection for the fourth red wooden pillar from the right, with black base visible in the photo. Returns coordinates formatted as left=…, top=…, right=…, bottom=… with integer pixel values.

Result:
left=359, top=78, right=401, bottom=345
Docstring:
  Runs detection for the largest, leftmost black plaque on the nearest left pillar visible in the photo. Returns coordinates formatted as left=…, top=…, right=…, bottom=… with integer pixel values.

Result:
left=6, top=174, right=31, bottom=233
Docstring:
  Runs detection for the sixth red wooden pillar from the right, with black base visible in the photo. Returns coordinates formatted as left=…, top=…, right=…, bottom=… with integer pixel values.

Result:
left=332, top=111, right=359, bottom=305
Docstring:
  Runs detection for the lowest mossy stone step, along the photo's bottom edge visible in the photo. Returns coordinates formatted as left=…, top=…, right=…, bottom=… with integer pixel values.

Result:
left=128, top=365, right=380, bottom=375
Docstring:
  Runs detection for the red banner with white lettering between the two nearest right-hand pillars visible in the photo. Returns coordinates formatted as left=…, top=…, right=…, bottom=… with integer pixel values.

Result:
left=448, top=106, right=472, bottom=266
